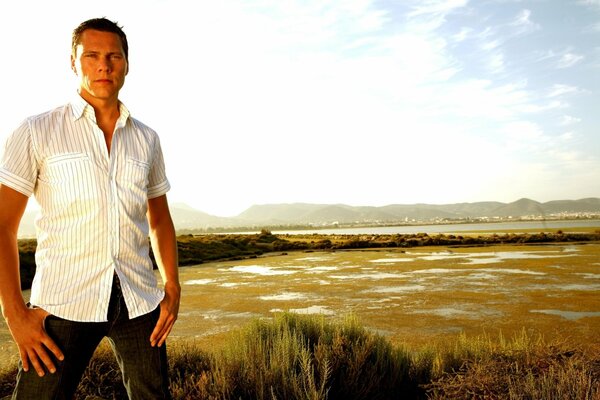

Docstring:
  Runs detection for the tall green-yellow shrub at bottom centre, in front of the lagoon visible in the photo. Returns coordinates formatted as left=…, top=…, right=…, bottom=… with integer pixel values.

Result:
left=214, top=313, right=420, bottom=400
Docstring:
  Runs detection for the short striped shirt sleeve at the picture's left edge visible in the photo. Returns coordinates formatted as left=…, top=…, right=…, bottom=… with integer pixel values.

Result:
left=0, top=121, right=38, bottom=197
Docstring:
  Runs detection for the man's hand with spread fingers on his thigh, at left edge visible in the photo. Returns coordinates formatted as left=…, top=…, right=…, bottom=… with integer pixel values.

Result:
left=6, top=308, right=64, bottom=376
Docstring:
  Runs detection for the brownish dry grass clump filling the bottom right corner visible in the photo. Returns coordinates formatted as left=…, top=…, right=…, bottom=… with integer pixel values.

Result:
left=426, top=333, right=600, bottom=400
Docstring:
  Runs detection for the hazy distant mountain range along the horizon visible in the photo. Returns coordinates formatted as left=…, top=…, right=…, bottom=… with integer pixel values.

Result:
left=19, top=197, right=600, bottom=237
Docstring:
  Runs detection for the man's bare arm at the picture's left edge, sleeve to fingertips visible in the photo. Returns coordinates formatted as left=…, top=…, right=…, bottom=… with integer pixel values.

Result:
left=0, top=185, right=63, bottom=376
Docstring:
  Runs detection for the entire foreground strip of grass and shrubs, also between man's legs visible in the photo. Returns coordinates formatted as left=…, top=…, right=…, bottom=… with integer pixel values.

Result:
left=0, top=313, right=600, bottom=400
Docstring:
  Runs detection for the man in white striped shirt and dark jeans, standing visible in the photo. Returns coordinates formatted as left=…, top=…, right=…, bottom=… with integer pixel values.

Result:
left=0, top=18, right=181, bottom=399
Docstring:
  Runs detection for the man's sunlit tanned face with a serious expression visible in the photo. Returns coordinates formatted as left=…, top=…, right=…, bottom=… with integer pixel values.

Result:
left=71, top=29, right=129, bottom=102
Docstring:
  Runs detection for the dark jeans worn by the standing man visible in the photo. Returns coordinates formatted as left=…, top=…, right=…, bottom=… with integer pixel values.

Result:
left=12, top=276, right=171, bottom=400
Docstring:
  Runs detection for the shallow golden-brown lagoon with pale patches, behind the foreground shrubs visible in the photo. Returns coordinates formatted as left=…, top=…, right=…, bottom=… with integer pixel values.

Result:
left=173, top=244, right=600, bottom=343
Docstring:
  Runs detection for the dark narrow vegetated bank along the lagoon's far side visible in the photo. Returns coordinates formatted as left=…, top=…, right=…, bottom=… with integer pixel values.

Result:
left=19, top=230, right=600, bottom=289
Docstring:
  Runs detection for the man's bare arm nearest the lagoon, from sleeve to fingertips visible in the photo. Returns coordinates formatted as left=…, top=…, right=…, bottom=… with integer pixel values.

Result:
left=148, top=195, right=181, bottom=346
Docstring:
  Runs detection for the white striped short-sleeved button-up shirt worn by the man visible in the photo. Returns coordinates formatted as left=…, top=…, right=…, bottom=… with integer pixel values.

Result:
left=0, top=96, right=170, bottom=322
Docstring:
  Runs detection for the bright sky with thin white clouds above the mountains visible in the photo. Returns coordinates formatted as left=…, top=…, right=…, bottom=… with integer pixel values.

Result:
left=0, top=0, right=600, bottom=216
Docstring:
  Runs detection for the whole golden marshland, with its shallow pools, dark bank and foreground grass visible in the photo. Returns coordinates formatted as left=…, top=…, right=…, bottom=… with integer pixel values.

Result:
left=0, top=232, right=600, bottom=399
